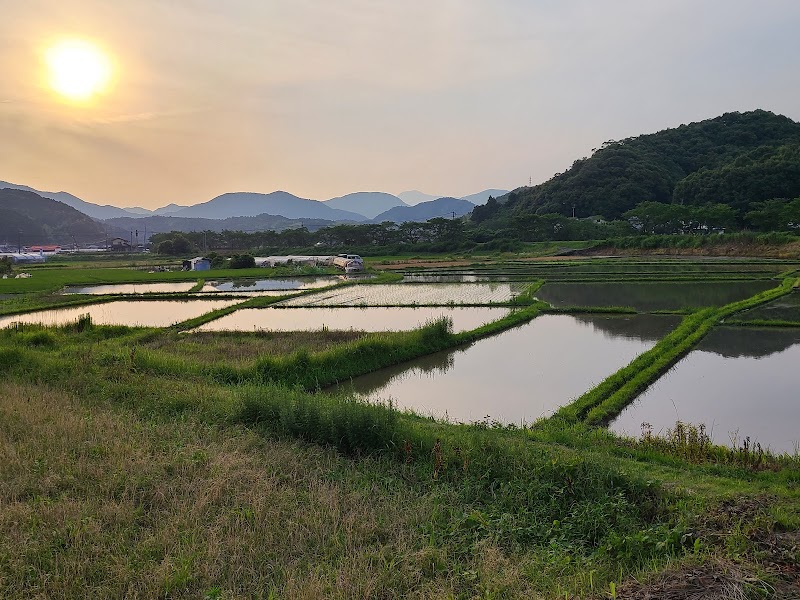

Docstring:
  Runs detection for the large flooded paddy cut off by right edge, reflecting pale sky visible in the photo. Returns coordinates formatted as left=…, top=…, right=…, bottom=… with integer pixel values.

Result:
left=610, top=327, right=800, bottom=452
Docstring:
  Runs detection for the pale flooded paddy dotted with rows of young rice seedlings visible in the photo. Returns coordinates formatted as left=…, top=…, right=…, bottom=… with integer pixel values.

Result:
left=283, top=283, right=528, bottom=306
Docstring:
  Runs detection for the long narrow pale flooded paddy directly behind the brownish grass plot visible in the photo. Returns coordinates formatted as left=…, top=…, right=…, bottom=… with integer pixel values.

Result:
left=194, top=307, right=509, bottom=332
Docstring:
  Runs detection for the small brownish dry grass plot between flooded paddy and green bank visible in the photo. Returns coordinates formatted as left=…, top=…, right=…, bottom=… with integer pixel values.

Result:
left=147, top=331, right=366, bottom=366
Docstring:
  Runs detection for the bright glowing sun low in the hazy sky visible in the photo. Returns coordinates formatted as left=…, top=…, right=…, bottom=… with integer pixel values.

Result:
left=45, top=39, right=112, bottom=102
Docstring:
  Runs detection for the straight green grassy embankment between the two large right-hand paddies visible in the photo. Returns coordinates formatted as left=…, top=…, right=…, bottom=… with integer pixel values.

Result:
left=553, top=278, right=795, bottom=425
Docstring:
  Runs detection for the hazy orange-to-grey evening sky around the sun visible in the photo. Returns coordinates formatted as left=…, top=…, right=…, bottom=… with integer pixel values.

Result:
left=0, top=0, right=800, bottom=209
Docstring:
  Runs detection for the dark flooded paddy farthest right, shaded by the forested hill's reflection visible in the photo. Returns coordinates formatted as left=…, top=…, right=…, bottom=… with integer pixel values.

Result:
left=536, top=281, right=777, bottom=311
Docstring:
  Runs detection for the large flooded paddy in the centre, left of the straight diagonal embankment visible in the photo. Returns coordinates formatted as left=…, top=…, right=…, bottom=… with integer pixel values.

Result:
left=330, top=315, right=679, bottom=424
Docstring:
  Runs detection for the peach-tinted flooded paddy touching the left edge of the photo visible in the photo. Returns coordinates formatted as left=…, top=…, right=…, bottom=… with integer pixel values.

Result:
left=0, top=300, right=236, bottom=328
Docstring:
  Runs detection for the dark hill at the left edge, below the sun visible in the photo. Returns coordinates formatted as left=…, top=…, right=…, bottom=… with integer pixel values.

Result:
left=0, top=189, right=105, bottom=246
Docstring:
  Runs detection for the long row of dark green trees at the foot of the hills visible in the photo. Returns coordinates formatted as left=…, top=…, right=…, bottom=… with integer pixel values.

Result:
left=151, top=198, right=800, bottom=256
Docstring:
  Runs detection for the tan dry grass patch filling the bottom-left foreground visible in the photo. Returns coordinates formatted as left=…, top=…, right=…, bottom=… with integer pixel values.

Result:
left=0, top=383, right=552, bottom=599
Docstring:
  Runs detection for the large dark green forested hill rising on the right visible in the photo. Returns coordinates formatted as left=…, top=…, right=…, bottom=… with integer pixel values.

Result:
left=482, top=110, right=800, bottom=221
